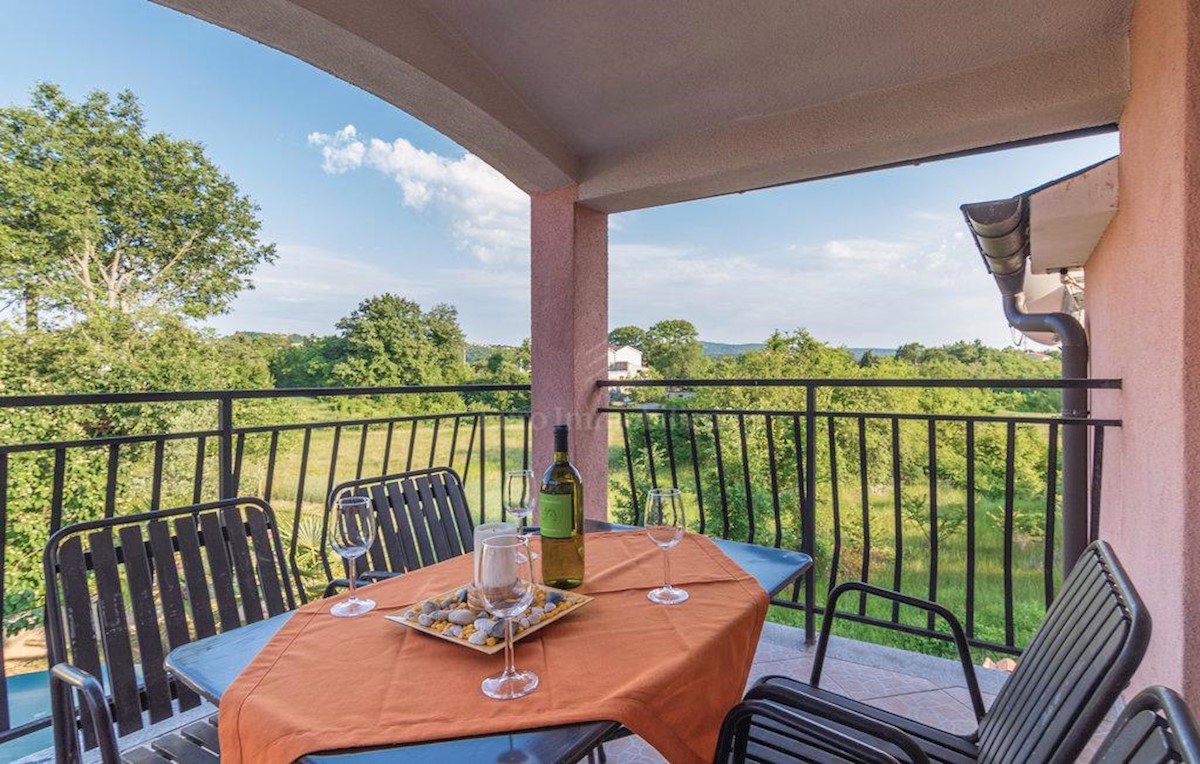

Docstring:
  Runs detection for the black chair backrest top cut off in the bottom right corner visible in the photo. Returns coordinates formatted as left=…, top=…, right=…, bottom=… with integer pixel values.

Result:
left=1092, top=686, right=1200, bottom=764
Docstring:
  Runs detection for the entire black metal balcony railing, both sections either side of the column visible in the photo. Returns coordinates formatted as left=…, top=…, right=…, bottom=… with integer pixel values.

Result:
left=0, top=380, right=1120, bottom=744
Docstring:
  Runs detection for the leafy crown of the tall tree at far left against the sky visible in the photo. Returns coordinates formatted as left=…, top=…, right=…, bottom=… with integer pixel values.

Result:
left=0, top=83, right=275, bottom=330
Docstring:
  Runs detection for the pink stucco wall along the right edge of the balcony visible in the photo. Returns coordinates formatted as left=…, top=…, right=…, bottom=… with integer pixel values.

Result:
left=1087, top=0, right=1200, bottom=708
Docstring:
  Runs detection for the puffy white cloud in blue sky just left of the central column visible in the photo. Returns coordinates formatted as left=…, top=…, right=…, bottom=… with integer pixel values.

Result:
left=308, top=125, right=529, bottom=266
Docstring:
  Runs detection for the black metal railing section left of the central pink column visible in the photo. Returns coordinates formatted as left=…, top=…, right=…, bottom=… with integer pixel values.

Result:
left=0, top=385, right=530, bottom=745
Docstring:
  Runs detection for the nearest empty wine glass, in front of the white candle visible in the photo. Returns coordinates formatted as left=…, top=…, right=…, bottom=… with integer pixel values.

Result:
left=475, top=536, right=538, bottom=700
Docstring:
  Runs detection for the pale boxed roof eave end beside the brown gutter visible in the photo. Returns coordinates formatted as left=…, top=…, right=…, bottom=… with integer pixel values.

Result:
left=1027, top=157, right=1118, bottom=273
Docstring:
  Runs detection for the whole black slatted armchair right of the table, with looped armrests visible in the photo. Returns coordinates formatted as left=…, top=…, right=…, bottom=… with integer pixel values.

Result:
left=719, top=541, right=1151, bottom=764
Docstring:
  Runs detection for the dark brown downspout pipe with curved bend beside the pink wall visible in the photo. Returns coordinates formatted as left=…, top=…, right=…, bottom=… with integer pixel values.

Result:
left=962, top=197, right=1090, bottom=574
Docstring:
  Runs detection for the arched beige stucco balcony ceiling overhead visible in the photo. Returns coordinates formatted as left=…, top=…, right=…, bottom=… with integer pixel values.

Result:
left=158, top=0, right=1130, bottom=212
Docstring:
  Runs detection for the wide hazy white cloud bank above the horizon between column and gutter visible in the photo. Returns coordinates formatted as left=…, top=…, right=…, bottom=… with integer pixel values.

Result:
left=610, top=228, right=1009, bottom=347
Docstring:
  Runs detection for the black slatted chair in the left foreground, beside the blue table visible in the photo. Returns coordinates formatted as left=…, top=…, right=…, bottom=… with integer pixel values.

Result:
left=44, top=498, right=302, bottom=764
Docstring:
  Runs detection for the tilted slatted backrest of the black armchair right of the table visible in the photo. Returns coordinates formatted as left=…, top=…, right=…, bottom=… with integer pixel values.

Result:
left=979, top=541, right=1150, bottom=763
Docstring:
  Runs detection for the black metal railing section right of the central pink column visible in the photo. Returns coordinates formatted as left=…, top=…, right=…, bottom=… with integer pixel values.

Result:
left=598, top=379, right=1121, bottom=654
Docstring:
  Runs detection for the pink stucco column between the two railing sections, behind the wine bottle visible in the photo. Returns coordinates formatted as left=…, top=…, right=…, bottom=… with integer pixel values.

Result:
left=530, top=186, right=608, bottom=519
